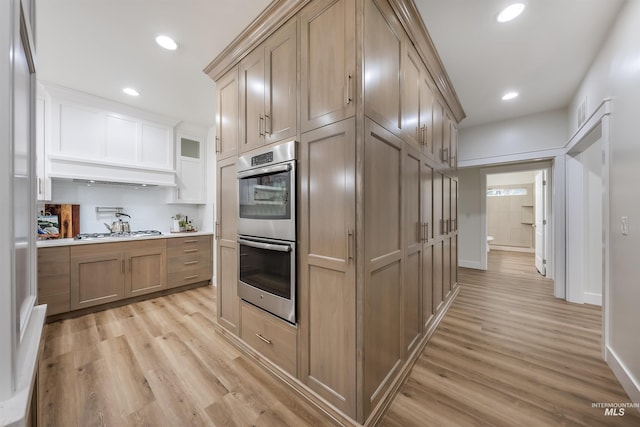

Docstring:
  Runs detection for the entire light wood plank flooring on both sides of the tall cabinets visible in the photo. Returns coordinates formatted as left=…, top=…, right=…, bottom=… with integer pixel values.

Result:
left=39, top=251, right=640, bottom=427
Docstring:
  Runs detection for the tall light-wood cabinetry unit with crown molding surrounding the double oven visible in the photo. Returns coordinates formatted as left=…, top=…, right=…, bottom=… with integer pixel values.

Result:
left=206, top=0, right=464, bottom=424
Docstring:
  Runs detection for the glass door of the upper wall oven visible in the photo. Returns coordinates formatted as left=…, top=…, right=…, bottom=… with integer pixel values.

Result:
left=238, top=164, right=293, bottom=220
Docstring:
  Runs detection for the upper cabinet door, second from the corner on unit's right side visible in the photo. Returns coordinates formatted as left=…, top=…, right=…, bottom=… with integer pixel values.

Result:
left=401, top=42, right=426, bottom=149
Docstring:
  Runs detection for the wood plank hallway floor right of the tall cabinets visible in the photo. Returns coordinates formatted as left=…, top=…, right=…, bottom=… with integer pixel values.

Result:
left=382, top=251, right=640, bottom=426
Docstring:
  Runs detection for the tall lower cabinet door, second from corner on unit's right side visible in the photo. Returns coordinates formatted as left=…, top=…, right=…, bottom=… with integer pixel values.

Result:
left=402, top=143, right=427, bottom=356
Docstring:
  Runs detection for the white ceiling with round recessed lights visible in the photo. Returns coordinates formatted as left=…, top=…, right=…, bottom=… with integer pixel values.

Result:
left=36, top=0, right=622, bottom=127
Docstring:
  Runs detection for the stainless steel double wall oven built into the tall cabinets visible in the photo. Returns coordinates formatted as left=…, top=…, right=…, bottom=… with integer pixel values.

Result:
left=237, top=141, right=296, bottom=323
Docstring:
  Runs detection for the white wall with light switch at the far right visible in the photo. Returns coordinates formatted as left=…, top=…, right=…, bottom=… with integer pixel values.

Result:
left=569, top=1, right=640, bottom=402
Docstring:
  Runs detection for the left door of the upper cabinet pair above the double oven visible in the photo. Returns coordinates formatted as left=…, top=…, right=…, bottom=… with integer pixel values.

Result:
left=239, top=45, right=267, bottom=153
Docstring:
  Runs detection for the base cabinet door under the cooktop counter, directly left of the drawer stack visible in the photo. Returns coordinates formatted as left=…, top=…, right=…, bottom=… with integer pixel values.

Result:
left=125, top=246, right=167, bottom=297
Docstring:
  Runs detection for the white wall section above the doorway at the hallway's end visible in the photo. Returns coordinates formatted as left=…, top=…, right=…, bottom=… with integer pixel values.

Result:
left=458, top=108, right=568, bottom=166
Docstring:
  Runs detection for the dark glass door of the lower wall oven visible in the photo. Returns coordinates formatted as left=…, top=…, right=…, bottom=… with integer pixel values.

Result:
left=238, top=238, right=295, bottom=300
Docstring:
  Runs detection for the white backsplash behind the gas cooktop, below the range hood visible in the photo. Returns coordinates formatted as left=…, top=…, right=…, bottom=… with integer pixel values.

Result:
left=38, top=180, right=213, bottom=233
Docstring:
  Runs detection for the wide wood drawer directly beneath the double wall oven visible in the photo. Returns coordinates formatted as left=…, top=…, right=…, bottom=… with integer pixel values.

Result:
left=240, top=302, right=297, bottom=376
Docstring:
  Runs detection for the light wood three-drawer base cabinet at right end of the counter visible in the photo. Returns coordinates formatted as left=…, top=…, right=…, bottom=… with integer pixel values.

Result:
left=167, top=236, right=213, bottom=288
